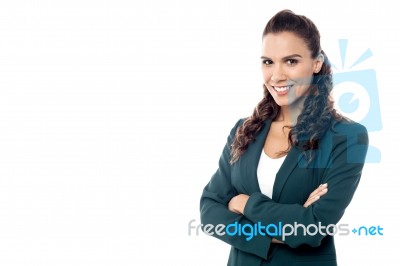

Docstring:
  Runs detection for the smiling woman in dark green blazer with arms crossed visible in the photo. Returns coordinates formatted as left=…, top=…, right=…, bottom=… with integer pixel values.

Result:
left=200, top=10, right=368, bottom=266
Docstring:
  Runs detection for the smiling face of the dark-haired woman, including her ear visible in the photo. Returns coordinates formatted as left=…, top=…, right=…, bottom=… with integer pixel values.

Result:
left=261, top=32, right=323, bottom=106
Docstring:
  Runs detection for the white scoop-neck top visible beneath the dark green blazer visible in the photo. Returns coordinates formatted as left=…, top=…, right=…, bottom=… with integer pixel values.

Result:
left=257, top=149, right=286, bottom=198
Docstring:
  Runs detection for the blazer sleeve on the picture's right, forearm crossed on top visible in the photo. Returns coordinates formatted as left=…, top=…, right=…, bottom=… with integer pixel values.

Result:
left=244, top=124, right=368, bottom=248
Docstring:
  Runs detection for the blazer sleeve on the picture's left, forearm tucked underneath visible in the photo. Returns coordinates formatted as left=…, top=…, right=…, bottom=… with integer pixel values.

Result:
left=200, top=120, right=271, bottom=259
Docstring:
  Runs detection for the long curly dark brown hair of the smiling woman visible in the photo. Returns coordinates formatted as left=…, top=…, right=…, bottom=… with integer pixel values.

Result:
left=231, top=10, right=344, bottom=164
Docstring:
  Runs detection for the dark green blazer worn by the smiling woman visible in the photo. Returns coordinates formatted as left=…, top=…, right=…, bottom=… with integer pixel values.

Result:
left=200, top=119, right=368, bottom=266
